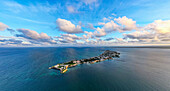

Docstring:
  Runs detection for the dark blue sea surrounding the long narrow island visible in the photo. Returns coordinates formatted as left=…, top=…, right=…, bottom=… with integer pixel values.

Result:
left=0, top=47, right=170, bottom=91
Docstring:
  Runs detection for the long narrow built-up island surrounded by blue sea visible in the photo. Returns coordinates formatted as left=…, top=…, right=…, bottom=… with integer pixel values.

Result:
left=49, top=50, right=120, bottom=73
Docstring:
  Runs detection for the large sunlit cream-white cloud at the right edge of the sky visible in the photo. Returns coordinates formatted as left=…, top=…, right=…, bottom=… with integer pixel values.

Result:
left=124, top=20, right=170, bottom=43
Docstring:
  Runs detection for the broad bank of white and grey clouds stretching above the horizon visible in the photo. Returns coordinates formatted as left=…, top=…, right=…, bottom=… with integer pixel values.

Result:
left=0, top=16, right=170, bottom=46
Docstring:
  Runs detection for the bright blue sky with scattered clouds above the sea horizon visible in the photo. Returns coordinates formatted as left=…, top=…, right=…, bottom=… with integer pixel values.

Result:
left=0, top=0, right=170, bottom=47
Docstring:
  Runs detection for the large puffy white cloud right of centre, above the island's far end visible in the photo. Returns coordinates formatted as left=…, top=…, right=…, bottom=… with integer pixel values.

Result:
left=90, top=16, right=139, bottom=37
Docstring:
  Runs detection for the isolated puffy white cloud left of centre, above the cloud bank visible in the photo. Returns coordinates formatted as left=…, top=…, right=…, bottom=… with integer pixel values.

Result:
left=56, top=18, right=83, bottom=33
